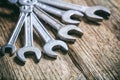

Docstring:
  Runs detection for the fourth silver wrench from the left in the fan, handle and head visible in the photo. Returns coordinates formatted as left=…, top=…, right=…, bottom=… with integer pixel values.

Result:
left=34, top=7, right=83, bottom=42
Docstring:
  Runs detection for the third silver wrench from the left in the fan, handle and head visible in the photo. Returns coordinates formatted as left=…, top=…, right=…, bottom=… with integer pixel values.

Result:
left=33, top=13, right=68, bottom=58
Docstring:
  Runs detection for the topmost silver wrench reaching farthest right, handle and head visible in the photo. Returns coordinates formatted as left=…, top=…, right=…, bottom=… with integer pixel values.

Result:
left=38, top=0, right=111, bottom=22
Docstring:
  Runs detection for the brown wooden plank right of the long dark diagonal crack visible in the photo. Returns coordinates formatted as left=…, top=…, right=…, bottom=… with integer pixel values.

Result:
left=67, top=0, right=120, bottom=80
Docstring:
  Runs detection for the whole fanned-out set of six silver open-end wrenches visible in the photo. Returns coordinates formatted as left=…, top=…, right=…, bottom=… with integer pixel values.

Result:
left=1, top=0, right=111, bottom=63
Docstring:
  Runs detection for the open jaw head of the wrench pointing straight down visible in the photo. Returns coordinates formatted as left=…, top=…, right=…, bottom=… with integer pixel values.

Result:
left=17, top=47, right=41, bottom=63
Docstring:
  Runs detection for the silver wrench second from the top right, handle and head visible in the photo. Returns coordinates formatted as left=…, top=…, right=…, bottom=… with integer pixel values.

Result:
left=36, top=3, right=83, bottom=24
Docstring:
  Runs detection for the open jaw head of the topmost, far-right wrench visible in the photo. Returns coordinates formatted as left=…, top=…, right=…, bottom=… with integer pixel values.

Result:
left=85, top=6, right=111, bottom=22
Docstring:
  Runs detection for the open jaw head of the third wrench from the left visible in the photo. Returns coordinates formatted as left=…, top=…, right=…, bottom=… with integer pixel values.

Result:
left=43, top=40, right=68, bottom=58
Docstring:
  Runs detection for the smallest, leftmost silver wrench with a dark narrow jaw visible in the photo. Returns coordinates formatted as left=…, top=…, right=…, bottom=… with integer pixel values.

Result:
left=1, top=6, right=29, bottom=55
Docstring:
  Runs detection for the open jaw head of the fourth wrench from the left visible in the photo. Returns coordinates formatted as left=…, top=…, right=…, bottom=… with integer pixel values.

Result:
left=58, top=25, right=83, bottom=43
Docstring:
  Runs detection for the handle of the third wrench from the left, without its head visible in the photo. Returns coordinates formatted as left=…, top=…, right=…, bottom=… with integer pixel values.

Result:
left=33, top=13, right=54, bottom=43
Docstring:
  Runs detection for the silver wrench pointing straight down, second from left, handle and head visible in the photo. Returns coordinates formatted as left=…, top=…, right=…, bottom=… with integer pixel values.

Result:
left=17, top=13, right=41, bottom=63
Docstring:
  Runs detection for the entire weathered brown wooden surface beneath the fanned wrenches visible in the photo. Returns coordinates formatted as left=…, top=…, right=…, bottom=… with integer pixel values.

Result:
left=0, top=0, right=120, bottom=80
